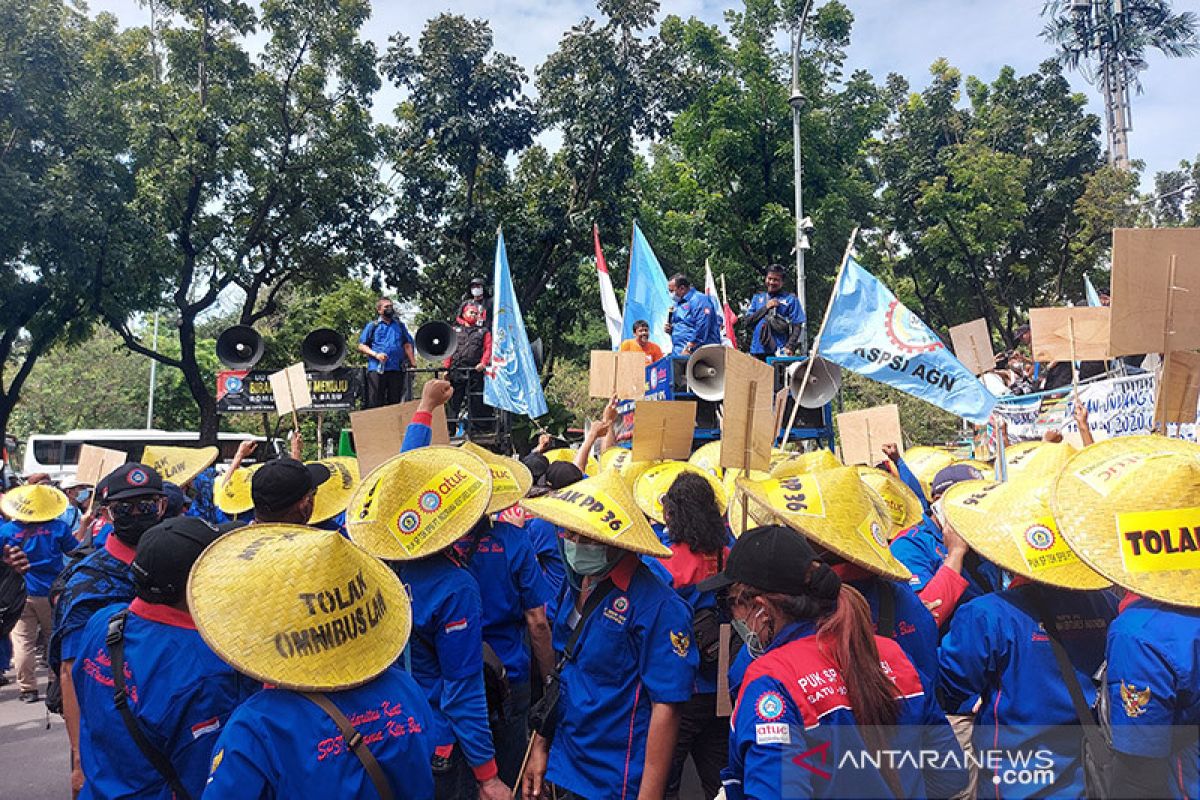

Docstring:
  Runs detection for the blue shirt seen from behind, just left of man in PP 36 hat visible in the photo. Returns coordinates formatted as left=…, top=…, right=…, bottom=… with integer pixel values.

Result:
left=455, top=522, right=550, bottom=682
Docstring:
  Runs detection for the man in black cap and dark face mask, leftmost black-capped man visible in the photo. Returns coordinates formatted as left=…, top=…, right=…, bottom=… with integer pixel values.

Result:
left=47, top=463, right=167, bottom=792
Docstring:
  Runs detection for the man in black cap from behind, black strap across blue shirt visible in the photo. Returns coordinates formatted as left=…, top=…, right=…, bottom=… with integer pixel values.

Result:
left=73, top=517, right=262, bottom=798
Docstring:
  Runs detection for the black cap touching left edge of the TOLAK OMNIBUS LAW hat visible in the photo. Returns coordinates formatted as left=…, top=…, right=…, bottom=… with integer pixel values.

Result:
left=130, top=517, right=221, bottom=604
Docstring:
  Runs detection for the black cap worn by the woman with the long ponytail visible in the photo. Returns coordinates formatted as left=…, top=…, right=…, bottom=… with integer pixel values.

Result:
left=696, top=525, right=817, bottom=595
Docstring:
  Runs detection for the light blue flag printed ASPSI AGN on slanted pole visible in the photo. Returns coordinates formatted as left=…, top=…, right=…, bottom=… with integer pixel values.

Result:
left=820, top=255, right=996, bottom=425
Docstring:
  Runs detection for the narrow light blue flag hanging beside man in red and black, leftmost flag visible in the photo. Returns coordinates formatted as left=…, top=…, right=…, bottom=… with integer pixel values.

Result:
left=484, top=231, right=546, bottom=417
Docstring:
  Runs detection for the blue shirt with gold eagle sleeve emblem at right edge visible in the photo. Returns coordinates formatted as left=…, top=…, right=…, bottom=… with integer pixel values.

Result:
left=1105, top=599, right=1200, bottom=798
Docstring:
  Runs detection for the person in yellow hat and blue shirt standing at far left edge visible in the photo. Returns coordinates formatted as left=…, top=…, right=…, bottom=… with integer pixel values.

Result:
left=0, top=485, right=79, bottom=703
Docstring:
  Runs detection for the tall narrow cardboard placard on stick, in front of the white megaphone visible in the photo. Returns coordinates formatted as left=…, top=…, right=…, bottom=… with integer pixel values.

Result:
left=721, top=348, right=775, bottom=471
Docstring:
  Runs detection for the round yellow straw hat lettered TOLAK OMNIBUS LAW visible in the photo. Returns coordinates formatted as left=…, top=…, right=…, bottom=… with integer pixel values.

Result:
left=187, top=524, right=413, bottom=692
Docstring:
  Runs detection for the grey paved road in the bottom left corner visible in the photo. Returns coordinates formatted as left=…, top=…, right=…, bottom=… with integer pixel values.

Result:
left=0, top=669, right=71, bottom=800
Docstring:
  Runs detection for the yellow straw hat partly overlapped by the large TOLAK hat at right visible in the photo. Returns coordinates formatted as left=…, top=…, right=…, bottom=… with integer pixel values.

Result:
left=942, top=474, right=1110, bottom=589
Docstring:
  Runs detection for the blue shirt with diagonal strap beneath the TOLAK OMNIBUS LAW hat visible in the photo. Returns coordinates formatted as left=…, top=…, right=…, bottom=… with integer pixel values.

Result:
left=204, top=667, right=433, bottom=800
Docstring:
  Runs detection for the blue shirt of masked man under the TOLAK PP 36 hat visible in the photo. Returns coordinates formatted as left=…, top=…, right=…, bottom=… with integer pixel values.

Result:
left=546, top=553, right=698, bottom=800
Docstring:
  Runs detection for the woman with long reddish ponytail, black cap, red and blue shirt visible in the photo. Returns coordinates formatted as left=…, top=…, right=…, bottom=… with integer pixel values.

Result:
left=700, top=527, right=966, bottom=800
